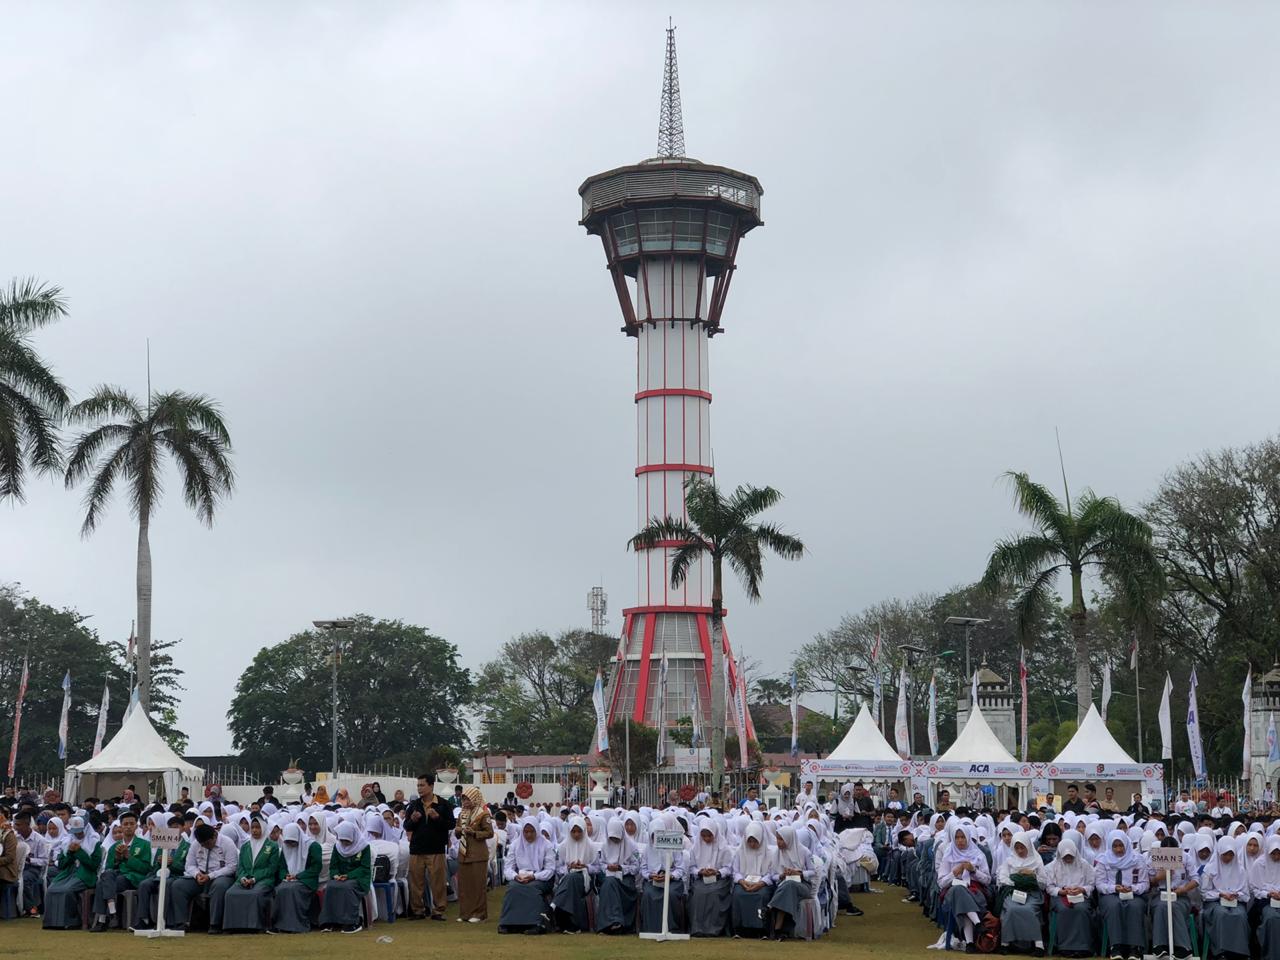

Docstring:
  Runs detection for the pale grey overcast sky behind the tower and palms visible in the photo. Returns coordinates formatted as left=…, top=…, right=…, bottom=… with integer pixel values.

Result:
left=0, top=0, right=1280, bottom=754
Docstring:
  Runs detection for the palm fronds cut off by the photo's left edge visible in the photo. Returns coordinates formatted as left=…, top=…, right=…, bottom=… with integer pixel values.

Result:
left=0, top=279, right=70, bottom=502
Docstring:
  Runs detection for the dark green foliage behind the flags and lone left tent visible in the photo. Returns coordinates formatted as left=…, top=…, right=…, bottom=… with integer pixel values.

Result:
left=0, top=584, right=186, bottom=780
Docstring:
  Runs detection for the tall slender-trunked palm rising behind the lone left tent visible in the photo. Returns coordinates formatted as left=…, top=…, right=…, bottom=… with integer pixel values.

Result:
left=67, top=387, right=236, bottom=708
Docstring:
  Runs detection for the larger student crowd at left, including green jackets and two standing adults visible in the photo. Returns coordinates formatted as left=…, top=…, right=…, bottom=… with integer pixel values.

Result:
left=0, top=776, right=877, bottom=940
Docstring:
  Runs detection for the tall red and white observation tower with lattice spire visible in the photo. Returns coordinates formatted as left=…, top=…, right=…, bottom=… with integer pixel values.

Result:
left=579, top=27, right=763, bottom=740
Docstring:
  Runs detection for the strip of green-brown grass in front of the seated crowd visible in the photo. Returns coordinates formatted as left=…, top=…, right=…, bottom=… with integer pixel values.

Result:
left=0, top=887, right=937, bottom=960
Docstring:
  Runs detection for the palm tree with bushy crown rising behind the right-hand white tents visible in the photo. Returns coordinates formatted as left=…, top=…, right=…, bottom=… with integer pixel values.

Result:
left=982, top=472, right=1164, bottom=722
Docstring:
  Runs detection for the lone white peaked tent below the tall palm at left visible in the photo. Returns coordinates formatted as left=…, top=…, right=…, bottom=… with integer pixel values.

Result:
left=63, top=707, right=205, bottom=803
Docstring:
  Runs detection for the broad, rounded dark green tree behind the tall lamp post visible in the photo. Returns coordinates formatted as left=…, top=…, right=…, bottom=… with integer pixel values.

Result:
left=227, top=614, right=472, bottom=771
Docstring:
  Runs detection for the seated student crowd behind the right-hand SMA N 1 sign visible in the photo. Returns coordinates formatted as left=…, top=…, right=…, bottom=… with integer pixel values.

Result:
left=873, top=790, right=1280, bottom=960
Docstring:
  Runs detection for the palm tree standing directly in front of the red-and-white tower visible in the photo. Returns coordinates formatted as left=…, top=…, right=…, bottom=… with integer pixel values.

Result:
left=628, top=476, right=804, bottom=790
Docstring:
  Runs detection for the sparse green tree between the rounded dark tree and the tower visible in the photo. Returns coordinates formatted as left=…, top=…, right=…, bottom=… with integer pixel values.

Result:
left=477, top=630, right=618, bottom=755
